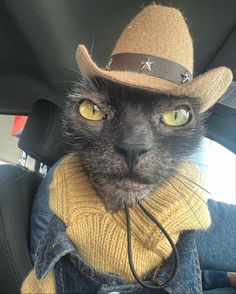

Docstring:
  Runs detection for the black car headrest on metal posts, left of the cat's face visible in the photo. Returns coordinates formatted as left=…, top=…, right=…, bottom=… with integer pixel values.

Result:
left=18, top=100, right=65, bottom=167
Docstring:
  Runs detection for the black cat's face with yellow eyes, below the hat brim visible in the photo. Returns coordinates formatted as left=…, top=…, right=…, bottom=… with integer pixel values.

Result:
left=64, top=78, right=205, bottom=211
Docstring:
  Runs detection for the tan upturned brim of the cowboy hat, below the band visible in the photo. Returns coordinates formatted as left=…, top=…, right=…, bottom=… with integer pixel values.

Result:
left=76, top=45, right=233, bottom=112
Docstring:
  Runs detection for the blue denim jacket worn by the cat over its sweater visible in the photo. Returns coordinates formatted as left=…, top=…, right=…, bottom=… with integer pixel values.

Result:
left=35, top=215, right=202, bottom=294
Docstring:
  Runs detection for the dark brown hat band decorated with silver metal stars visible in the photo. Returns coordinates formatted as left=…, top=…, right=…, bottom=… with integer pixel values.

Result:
left=106, top=53, right=193, bottom=84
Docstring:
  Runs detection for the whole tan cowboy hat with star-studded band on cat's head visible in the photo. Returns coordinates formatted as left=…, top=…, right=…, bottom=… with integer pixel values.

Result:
left=76, top=4, right=232, bottom=112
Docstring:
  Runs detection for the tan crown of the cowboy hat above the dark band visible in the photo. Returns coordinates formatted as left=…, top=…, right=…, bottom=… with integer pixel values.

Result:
left=112, top=4, right=193, bottom=74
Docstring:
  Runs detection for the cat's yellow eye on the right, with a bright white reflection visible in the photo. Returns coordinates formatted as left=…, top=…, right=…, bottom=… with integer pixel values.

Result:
left=162, top=108, right=191, bottom=127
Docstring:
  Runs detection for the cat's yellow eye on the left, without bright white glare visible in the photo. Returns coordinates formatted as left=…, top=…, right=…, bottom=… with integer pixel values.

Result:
left=79, top=100, right=106, bottom=121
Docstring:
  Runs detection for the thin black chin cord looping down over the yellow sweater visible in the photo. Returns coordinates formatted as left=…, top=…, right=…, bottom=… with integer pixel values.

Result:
left=125, top=203, right=179, bottom=289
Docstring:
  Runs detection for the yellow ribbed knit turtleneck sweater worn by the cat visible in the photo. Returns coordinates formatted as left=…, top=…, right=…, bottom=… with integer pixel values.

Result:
left=22, top=155, right=210, bottom=293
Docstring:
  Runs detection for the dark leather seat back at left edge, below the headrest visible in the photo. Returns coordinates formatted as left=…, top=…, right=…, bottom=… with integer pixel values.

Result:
left=0, top=165, right=41, bottom=293
